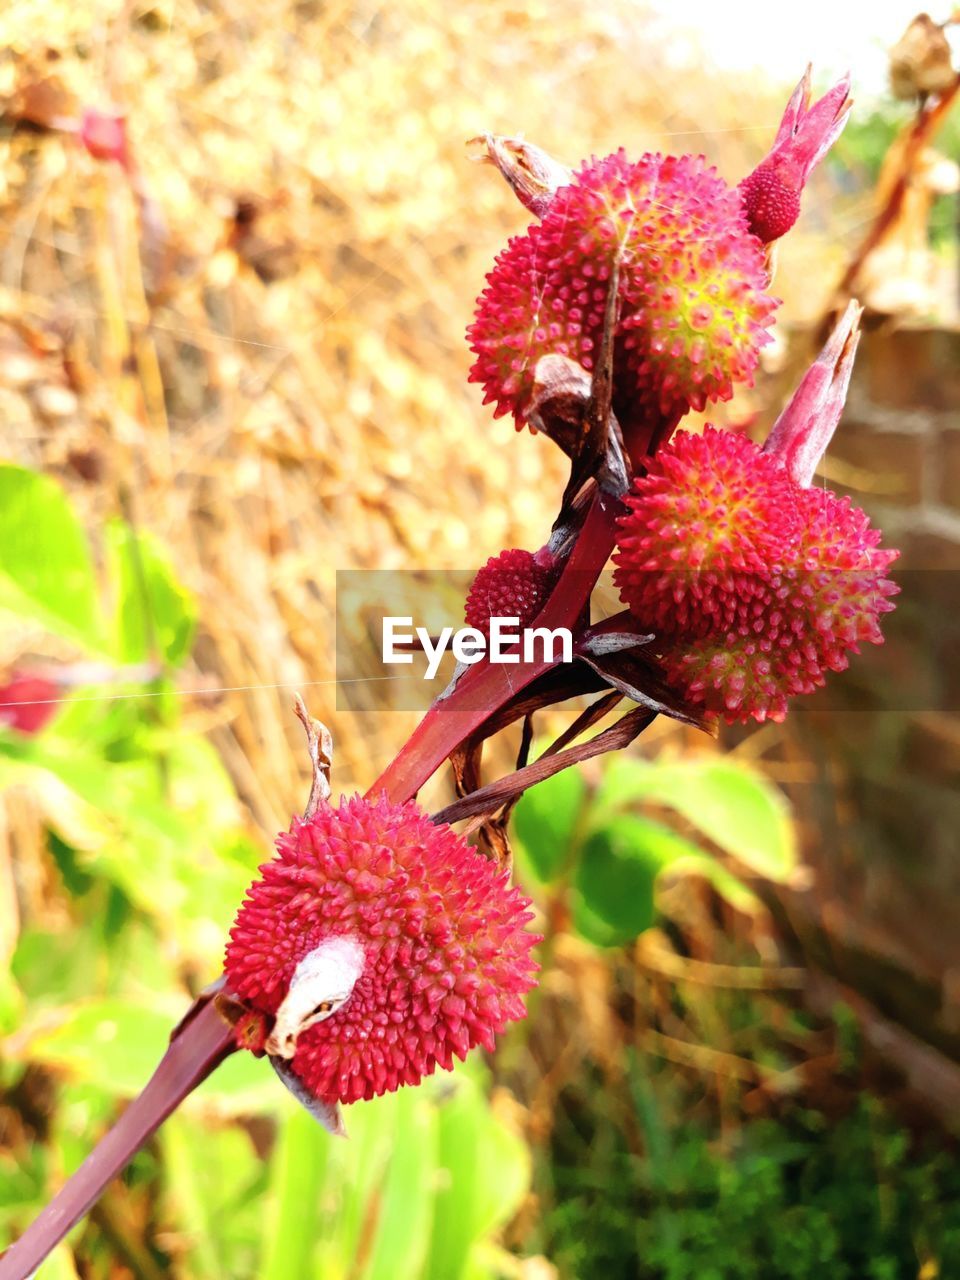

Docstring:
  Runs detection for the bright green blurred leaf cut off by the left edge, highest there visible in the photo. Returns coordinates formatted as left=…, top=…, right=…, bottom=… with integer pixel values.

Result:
left=0, top=466, right=104, bottom=653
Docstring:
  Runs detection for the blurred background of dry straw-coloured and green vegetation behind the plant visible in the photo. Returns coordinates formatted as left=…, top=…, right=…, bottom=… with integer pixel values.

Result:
left=0, top=0, right=960, bottom=1280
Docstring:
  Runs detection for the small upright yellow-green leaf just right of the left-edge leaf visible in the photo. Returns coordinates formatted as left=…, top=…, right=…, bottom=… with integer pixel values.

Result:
left=106, top=520, right=196, bottom=666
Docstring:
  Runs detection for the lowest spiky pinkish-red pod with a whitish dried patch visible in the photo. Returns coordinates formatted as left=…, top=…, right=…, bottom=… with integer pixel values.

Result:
left=225, top=796, right=539, bottom=1102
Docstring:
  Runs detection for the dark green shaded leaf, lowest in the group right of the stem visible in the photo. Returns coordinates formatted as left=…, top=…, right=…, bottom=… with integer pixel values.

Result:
left=573, top=814, right=698, bottom=946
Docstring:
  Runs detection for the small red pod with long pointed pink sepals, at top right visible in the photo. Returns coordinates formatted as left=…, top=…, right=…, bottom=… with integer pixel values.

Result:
left=740, top=67, right=851, bottom=244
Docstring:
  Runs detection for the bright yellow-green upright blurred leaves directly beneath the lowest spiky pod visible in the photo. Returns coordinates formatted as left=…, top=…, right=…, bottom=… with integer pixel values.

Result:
left=154, top=1071, right=530, bottom=1280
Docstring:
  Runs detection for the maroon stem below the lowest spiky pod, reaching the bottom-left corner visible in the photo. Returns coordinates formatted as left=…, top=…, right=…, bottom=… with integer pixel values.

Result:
left=0, top=1000, right=236, bottom=1280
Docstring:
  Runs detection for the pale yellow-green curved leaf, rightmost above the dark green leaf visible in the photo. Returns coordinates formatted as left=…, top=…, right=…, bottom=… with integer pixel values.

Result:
left=596, top=758, right=796, bottom=881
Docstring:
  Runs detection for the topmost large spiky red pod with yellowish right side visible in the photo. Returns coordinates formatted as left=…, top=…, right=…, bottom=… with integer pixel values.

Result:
left=468, top=150, right=776, bottom=455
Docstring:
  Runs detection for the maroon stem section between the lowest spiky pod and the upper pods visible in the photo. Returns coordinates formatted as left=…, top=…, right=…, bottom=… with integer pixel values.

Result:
left=367, top=492, right=620, bottom=803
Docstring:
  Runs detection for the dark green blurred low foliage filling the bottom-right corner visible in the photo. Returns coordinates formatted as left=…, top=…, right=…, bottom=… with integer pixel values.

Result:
left=538, top=1080, right=960, bottom=1280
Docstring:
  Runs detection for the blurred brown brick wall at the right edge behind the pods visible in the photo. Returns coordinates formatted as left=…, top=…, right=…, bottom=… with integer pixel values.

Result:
left=786, top=329, right=960, bottom=1029
